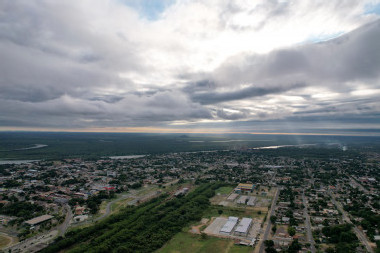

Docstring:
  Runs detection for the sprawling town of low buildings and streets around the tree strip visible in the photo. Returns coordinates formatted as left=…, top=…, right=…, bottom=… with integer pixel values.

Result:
left=0, top=148, right=380, bottom=253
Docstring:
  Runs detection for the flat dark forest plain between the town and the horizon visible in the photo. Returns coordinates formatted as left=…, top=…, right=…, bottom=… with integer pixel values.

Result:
left=0, top=132, right=380, bottom=159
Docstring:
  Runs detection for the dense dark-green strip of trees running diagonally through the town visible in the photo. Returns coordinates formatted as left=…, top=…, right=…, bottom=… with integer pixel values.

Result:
left=42, top=183, right=223, bottom=253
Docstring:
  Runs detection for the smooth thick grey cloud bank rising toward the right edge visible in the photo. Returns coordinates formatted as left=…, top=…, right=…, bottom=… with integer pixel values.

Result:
left=212, top=21, right=380, bottom=89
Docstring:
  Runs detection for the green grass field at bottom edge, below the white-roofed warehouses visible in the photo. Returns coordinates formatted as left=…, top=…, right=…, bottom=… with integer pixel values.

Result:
left=156, top=232, right=252, bottom=253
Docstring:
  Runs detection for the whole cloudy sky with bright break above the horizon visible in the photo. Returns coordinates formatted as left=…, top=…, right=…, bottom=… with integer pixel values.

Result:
left=0, top=0, right=380, bottom=135
